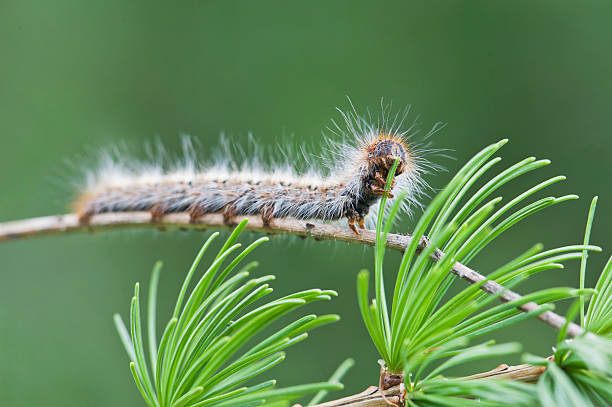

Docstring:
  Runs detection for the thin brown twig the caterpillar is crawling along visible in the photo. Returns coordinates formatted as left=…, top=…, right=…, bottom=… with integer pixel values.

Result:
left=0, top=212, right=584, bottom=337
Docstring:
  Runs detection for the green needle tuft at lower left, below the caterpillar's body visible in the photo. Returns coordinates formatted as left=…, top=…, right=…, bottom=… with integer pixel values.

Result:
left=115, top=221, right=350, bottom=407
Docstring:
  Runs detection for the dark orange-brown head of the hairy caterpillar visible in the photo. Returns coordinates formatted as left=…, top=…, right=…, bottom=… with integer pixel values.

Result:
left=367, top=135, right=410, bottom=177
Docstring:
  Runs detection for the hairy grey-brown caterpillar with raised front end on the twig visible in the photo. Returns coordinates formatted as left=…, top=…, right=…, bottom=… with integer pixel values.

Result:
left=75, top=108, right=438, bottom=234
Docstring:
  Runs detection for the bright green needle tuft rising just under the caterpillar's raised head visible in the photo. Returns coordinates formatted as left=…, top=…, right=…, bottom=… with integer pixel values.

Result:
left=357, top=140, right=600, bottom=376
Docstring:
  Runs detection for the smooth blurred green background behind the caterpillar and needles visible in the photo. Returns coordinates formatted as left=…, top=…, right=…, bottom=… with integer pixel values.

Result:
left=0, top=0, right=612, bottom=406
